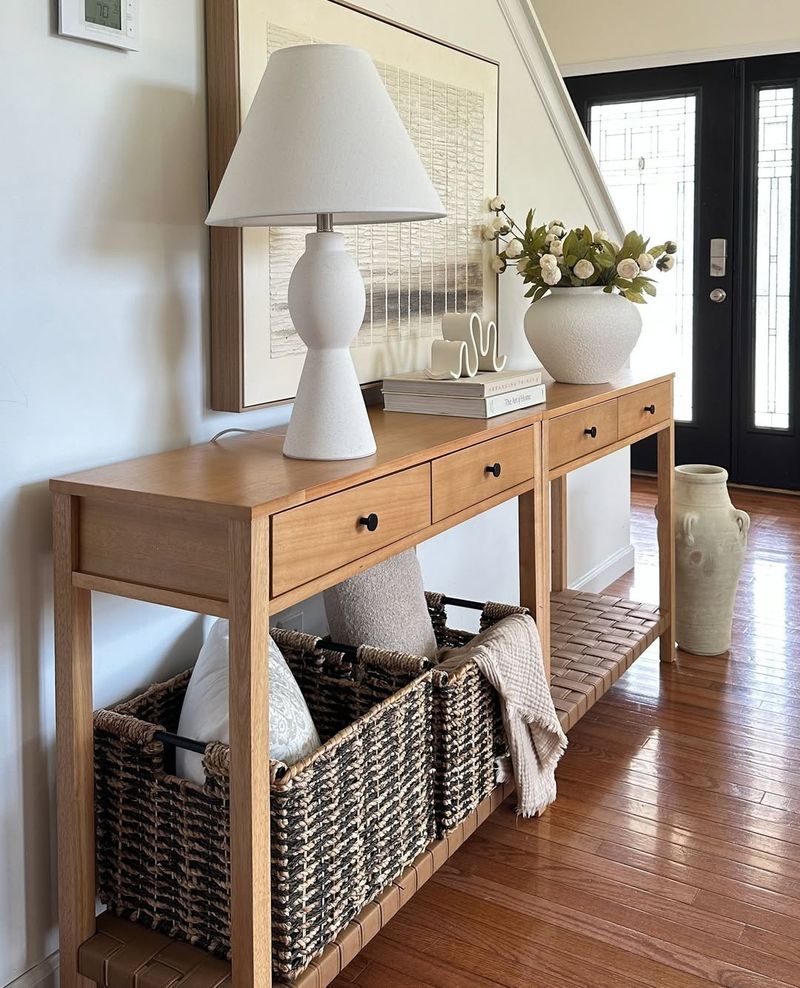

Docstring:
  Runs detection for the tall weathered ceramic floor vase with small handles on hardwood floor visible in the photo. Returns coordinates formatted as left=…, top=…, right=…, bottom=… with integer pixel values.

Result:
left=675, top=464, right=750, bottom=655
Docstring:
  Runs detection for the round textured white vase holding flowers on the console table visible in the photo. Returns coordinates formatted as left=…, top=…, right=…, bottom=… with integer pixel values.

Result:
left=525, top=287, right=642, bottom=384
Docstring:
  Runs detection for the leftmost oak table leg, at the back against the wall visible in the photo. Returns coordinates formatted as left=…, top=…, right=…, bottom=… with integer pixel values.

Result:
left=53, top=494, right=95, bottom=988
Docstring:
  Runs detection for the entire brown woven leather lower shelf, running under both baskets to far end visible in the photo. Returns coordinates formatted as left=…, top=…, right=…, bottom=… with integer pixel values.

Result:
left=78, top=590, right=667, bottom=988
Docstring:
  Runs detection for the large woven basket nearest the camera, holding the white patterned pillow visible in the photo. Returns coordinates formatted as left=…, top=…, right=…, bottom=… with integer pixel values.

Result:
left=95, top=630, right=435, bottom=978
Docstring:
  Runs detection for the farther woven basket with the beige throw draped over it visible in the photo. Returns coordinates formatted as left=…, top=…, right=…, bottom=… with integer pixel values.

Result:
left=425, top=593, right=530, bottom=837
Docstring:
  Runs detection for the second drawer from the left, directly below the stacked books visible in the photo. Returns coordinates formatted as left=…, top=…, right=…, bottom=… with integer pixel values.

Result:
left=432, top=429, right=533, bottom=522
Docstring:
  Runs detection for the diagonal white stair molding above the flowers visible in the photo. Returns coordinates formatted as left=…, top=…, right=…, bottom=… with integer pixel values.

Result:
left=497, top=0, right=624, bottom=240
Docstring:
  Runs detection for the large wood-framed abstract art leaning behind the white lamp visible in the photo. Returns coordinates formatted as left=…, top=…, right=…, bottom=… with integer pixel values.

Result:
left=207, top=0, right=499, bottom=411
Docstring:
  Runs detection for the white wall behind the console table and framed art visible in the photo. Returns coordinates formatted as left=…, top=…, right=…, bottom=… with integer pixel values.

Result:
left=0, top=0, right=628, bottom=984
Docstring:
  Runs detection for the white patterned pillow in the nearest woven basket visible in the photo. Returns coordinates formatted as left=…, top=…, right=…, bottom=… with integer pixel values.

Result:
left=175, top=618, right=320, bottom=785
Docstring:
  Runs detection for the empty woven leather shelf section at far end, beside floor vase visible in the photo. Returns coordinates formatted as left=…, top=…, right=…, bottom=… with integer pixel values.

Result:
left=550, top=590, right=667, bottom=731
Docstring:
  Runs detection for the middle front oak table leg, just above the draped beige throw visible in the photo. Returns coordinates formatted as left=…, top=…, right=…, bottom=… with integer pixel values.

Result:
left=519, top=422, right=550, bottom=681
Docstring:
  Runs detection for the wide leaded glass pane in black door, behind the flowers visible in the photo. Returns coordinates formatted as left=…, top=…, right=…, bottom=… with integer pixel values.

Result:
left=589, top=94, right=697, bottom=422
